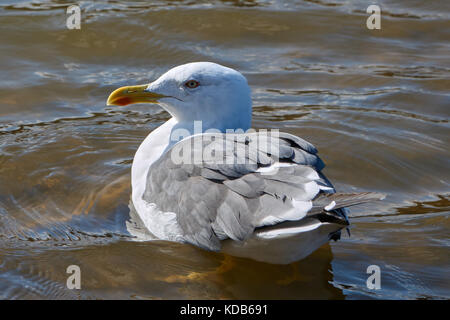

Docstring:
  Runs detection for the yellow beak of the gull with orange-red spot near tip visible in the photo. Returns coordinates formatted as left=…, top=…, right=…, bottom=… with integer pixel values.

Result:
left=106, top=84, right=166, bottom=106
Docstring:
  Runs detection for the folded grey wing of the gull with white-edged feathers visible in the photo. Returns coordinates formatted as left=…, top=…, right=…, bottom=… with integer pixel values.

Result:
left=143, top=133, right=380, bottom=251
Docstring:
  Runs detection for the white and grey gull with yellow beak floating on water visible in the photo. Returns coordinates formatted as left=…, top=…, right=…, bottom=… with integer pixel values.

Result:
left=108, top=62, right=382, bottom=263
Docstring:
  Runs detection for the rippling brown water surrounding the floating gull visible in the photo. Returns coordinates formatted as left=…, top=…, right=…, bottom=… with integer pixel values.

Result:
left=0, top=0, right=450, bottom=299
